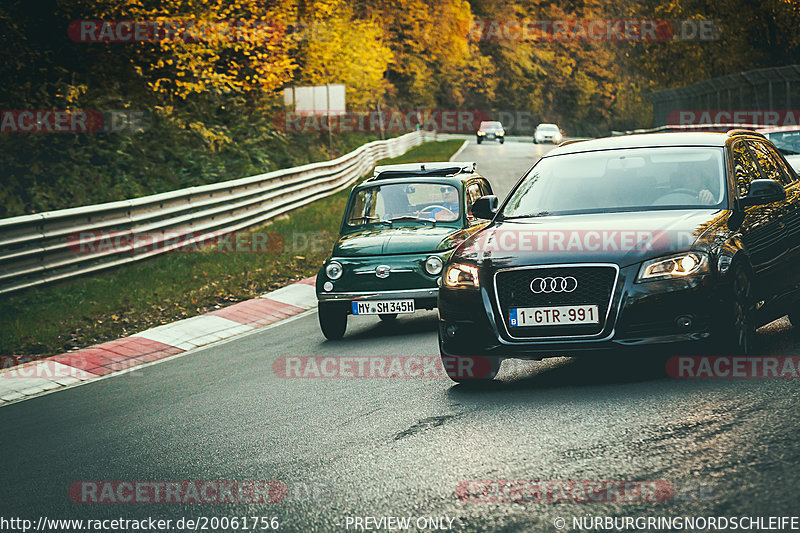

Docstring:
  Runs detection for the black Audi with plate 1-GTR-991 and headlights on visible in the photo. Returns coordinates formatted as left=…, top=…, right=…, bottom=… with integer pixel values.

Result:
left=438, top=130, right=800, bottom=381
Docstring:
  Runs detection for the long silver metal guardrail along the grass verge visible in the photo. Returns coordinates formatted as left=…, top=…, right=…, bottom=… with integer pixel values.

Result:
left=0, top=131, right=436, bottom=294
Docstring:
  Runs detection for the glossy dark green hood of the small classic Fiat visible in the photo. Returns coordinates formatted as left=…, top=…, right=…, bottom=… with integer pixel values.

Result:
left=333, top=225, right=467, bottom=257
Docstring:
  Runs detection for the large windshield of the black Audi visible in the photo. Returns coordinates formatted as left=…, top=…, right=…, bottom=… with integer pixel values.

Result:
left=503, top=147, right=725, bottom=218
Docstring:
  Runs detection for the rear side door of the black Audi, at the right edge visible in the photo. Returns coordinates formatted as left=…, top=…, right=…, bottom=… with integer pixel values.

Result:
left=750, top=140, right=800, bottom=296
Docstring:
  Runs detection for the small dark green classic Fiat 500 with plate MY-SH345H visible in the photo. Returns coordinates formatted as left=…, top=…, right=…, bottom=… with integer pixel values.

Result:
left=317, top=162, right=492, bottom=340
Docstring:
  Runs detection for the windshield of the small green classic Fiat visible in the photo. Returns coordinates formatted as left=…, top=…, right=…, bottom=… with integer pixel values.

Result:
left=346, top=183, right=460, bottom=226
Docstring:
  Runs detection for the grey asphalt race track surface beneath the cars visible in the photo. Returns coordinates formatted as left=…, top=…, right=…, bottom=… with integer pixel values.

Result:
left=0, top=139, right=800, bottom=532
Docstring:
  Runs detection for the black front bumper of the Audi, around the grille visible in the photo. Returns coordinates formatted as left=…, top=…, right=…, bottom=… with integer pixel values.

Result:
left=438, top=265, right=721, bottom=359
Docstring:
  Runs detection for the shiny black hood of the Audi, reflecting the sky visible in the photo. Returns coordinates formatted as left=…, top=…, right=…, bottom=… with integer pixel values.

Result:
left=455, top=209, right=728, bottom=267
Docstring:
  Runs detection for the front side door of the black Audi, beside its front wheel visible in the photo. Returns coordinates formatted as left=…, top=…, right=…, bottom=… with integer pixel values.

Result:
left=731, top=139, right=786, bottom=300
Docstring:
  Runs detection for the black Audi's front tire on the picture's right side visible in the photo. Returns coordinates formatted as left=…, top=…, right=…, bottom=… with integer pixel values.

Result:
left=719, top=263, right=756, bottom=355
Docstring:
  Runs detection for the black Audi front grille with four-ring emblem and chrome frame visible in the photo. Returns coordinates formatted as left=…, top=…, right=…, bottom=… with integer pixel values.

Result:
left=494, top=265, right=619, bottom=339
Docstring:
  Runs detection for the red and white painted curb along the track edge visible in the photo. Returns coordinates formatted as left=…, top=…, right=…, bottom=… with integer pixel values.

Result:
left=0, top=277, right=317, bottom=407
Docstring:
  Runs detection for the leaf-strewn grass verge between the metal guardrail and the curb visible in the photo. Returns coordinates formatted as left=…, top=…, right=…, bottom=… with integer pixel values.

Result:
left=0, top=140, right=463, bottom=357
